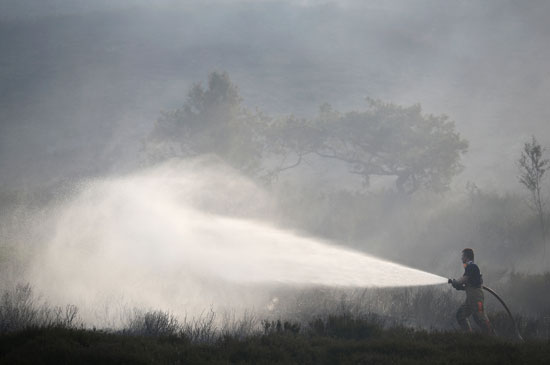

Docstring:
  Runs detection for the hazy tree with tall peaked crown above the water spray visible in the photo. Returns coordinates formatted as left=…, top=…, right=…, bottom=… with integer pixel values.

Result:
left=146, top=72, right=264, bottom=174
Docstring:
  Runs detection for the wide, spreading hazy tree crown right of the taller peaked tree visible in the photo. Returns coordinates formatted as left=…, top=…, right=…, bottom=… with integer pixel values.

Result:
left=268, top=99, right=468, bottom=193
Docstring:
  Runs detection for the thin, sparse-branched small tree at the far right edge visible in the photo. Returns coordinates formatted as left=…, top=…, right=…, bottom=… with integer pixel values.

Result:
left=519, top=136, right=550, bottom=259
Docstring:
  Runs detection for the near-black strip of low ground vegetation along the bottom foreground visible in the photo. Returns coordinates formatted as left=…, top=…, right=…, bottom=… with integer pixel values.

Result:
left=0, top=317, right=550, bottom=364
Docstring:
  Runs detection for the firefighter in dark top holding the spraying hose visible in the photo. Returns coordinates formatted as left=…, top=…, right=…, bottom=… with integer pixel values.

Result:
left=450, top=248, right=494, bottom=335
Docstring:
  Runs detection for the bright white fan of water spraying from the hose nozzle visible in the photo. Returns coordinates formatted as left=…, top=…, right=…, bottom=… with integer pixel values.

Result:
left=24, top=159, right=445, bottom=324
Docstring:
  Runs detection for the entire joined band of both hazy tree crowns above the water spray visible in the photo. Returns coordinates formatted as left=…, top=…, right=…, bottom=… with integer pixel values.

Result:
left=147, top=72, right=468, bottom=193
